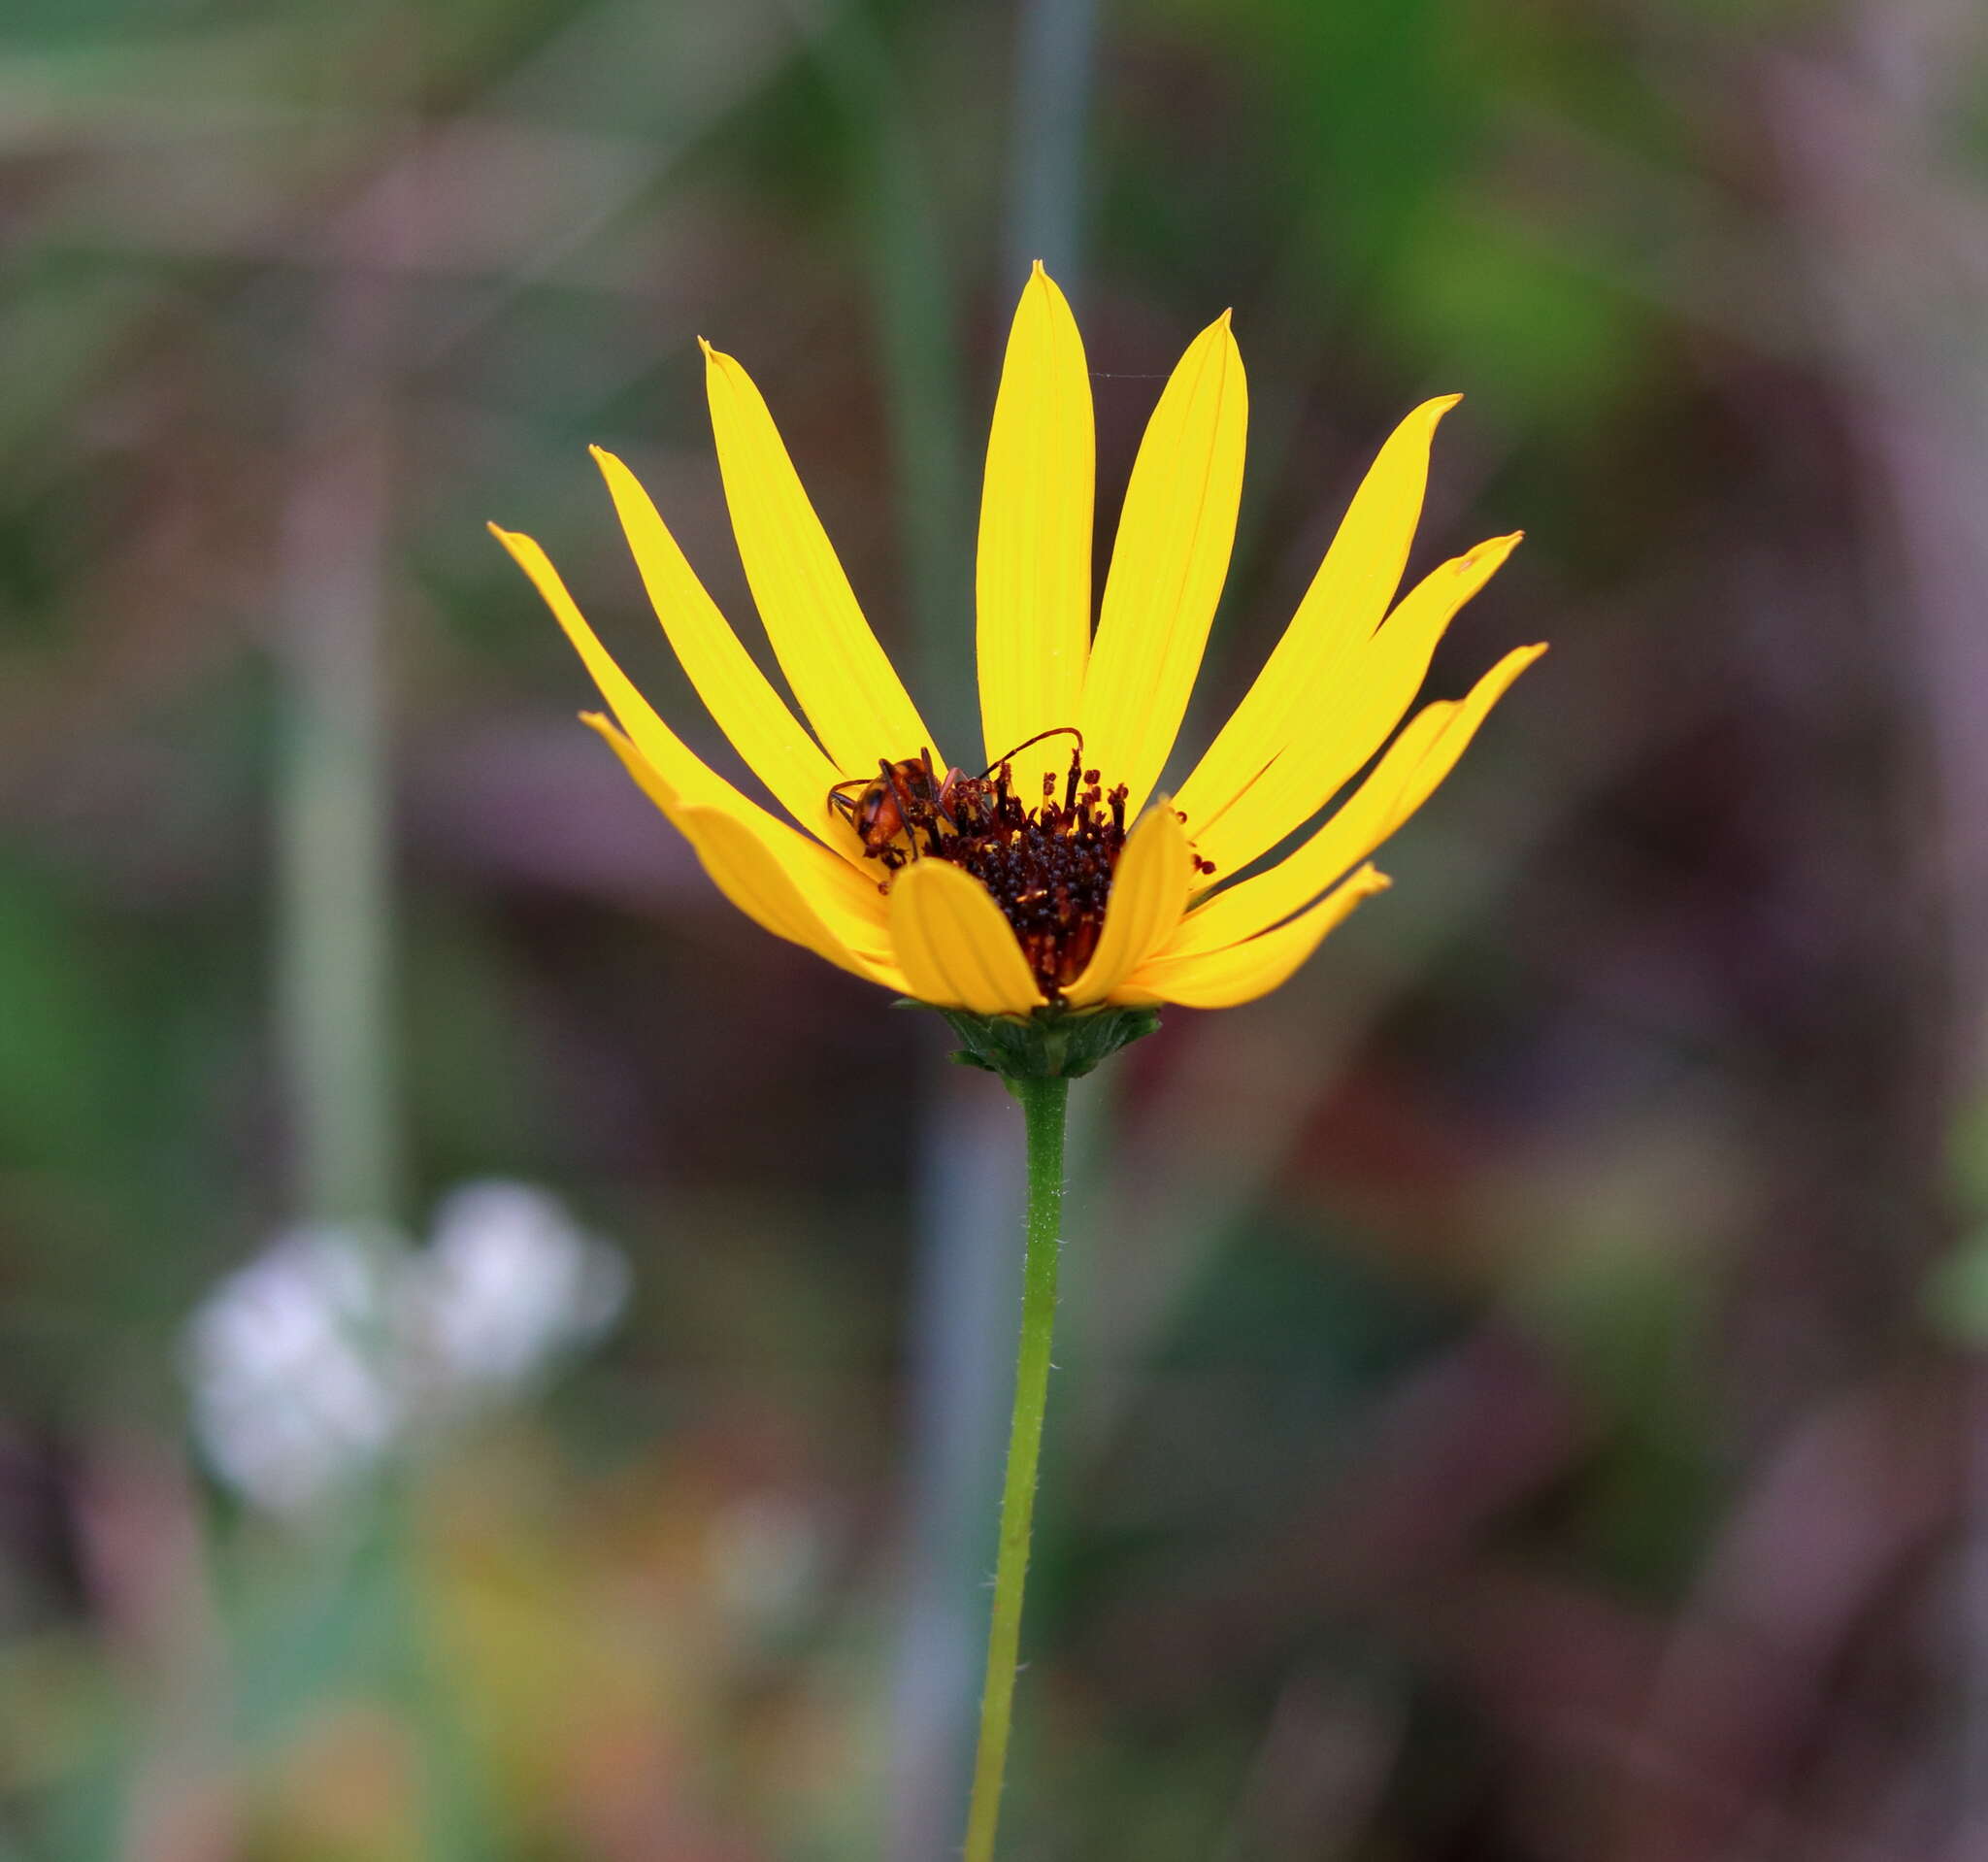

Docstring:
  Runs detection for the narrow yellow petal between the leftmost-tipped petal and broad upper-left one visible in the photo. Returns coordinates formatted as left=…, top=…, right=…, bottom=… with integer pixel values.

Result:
left=592, top=448, right=846, bottom=860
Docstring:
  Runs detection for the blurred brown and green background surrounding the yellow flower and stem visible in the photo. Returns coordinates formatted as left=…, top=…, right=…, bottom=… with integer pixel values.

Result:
left=0, top=0, right=1988, bottom=1862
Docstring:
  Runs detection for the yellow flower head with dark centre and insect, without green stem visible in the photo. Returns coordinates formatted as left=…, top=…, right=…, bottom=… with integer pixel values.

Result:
left=493, top=264, right=1544, bottom=1015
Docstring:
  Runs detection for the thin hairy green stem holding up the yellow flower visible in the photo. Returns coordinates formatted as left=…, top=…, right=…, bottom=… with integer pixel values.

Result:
left=966, top=1079, right=1070, bottom=1862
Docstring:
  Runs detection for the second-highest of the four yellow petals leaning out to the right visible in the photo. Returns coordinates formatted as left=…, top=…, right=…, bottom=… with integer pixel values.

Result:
left=1187, top=535, right=1519, bottom=879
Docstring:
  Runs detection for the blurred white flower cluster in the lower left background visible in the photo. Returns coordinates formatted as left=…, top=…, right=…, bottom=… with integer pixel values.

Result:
left=182, top=1182, right=628, bottom=1514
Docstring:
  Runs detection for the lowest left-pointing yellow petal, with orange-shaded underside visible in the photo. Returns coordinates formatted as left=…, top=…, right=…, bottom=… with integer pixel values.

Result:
left=580, top=712, right=903, bottom=989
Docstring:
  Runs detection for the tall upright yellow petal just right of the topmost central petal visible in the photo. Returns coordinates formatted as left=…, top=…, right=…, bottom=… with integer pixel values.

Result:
left=1073, top=310, right=1248, bottom=824
